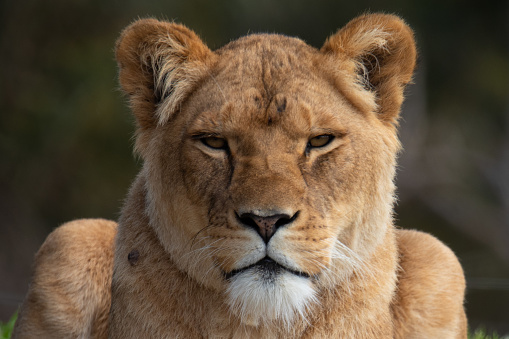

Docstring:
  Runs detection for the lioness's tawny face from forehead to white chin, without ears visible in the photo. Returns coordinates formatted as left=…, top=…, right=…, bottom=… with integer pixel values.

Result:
left=144, top=37, right=395, bottom=322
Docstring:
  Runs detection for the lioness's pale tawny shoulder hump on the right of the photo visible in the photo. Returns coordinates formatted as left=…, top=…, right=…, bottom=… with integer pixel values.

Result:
left=393, top=230, right=466, bottom=338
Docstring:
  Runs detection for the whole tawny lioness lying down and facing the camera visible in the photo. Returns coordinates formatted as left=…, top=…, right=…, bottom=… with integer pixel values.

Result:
left=14, top=14, right=466, bottom=339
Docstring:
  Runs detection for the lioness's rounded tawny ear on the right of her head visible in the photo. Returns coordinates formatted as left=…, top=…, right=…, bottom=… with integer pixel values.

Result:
left=321, top=14, right=417, bottom=125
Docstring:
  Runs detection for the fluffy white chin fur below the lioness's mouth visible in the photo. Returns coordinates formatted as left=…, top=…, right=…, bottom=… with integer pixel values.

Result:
left=227, top=269, right=316, bottom=327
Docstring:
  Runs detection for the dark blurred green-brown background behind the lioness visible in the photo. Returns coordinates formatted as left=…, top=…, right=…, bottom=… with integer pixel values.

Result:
left=0, top=0, right=509, bottom=334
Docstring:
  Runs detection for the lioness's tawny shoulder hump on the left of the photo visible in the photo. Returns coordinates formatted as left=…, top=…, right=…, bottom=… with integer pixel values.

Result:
left=13, top=219, right=117, bottom=338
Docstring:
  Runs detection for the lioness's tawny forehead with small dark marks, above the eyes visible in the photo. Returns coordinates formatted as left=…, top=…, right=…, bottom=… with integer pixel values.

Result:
left=181, top=35, right=360, bottom=137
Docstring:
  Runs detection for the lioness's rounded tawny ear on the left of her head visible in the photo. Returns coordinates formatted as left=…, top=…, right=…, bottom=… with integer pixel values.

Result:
left=115, top=19, right=215, bottom=151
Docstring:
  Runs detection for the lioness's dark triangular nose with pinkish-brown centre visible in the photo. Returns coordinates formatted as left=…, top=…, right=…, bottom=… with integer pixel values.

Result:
left=237, top=212, right=299, bottom=244
